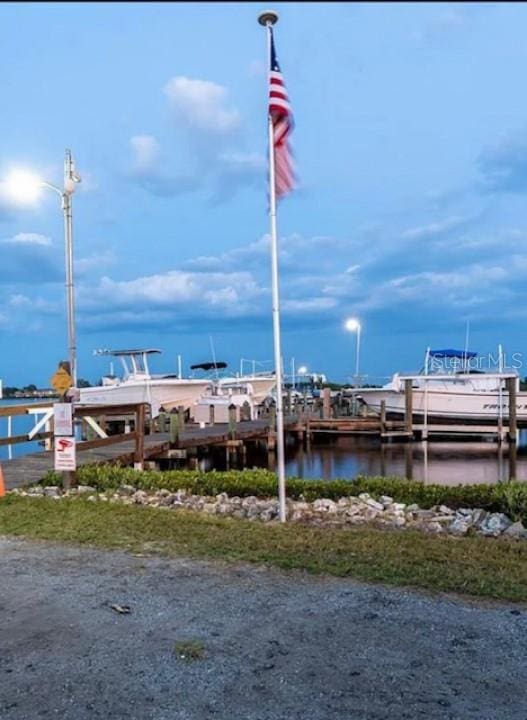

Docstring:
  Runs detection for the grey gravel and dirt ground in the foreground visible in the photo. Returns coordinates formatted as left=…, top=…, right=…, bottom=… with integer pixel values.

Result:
left=0, top=538, right=527, bottom=720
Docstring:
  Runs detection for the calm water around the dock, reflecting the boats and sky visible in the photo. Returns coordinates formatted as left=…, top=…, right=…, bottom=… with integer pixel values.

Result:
left=0, top=400, right=527, bottom=485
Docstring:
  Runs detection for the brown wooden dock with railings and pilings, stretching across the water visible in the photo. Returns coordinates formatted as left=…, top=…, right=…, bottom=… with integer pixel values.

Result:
left=0, top=390, right=518, bottom=489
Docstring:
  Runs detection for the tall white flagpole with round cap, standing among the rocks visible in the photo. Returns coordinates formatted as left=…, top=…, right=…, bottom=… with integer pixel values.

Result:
left=258, top=10, right=287, bottom=522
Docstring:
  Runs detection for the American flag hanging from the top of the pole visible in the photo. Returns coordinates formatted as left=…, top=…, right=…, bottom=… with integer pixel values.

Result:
left=269, top=28, right=295, bottom=199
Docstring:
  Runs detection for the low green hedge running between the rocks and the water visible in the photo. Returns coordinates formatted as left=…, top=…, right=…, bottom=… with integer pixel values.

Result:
left=43, top=465, right=527, bottom=524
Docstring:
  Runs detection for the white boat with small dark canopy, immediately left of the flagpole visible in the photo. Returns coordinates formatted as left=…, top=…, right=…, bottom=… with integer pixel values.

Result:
left=191, top=362, right=276, bottom=422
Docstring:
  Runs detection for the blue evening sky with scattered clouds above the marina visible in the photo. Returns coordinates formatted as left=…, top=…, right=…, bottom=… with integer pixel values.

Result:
left=0, top=3, right=527, bottom=385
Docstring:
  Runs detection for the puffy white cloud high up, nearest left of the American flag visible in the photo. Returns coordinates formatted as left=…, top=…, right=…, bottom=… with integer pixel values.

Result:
left=163, top=75, right=241, bottom=135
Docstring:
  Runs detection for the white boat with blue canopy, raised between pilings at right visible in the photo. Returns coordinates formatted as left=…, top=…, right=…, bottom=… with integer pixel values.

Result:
left=357, top=350, right=527, bottom=422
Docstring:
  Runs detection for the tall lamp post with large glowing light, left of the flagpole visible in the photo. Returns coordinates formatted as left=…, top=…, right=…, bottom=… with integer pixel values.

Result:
left=5, top=150, right=81, bottom=387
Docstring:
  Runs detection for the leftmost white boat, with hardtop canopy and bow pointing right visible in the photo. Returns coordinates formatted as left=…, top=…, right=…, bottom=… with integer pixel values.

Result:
left=79, top=349, right=209, bottom=417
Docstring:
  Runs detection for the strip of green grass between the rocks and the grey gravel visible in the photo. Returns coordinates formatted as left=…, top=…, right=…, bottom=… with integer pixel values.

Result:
left=0, top=495, right=527, bottom=601
